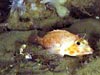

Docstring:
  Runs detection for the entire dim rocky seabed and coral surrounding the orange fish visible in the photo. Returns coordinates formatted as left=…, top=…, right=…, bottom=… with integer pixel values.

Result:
left=0, top=0, right=100, bottom=75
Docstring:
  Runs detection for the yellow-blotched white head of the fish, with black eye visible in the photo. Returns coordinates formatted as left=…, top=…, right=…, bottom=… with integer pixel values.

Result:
left=65, top=38, right=93, bottom=56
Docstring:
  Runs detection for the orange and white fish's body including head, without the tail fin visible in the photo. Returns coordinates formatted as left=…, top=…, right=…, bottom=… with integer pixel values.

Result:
left=38, top=30, right=93, bottom=56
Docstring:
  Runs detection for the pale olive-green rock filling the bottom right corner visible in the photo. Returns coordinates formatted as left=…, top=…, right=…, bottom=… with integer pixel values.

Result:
left=75, top=58, right=100, bottom=75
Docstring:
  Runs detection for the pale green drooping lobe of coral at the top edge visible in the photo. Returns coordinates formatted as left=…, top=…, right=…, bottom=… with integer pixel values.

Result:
left=42, top=0, right=70, bottom=17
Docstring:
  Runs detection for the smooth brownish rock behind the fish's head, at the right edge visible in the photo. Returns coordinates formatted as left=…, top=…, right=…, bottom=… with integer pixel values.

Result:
left=68, top=18, right=100, bottom=34
